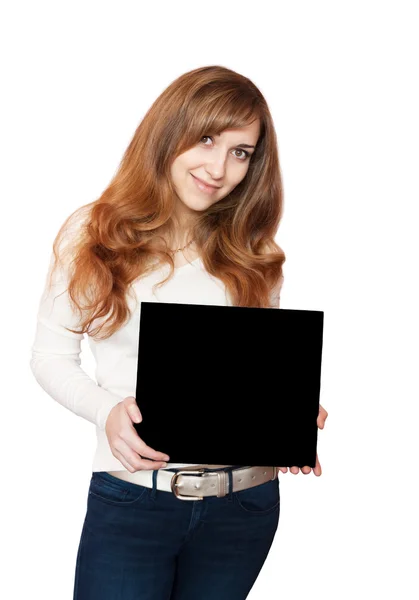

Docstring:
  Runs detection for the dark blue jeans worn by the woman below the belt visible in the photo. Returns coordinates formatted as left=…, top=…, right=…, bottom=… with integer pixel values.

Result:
left=73, top=467, right=280, bottom=600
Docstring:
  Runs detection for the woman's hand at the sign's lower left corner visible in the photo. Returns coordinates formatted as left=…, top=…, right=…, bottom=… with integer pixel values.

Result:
left=105, top=396, right=170, bottom=473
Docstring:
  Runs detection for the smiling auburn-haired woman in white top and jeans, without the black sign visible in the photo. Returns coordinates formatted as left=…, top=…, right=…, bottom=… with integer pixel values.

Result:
left=31, top=66, right=327, bottom=600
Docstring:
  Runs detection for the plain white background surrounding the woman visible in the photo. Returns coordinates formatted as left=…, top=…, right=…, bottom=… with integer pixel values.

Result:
left=0, top=0, right=419, bottom=600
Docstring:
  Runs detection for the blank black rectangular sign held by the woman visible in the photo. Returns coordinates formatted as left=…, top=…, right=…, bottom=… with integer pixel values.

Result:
left=134, top=302, right=324, bottom=468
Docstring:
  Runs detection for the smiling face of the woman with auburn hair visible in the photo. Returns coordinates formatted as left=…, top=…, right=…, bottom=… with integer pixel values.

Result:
left=171, top=119, right=260, bottom=216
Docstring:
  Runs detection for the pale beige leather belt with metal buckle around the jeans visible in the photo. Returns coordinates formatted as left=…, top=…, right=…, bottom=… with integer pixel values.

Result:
left=107, top=467, right=278, bottom=500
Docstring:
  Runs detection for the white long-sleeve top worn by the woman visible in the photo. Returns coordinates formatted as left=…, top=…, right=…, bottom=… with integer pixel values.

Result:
left=30, top=237, right=279, bottom=471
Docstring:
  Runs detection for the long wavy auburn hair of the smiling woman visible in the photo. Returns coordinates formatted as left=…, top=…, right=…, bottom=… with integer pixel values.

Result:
left=50, top=65, right=285, bottom=339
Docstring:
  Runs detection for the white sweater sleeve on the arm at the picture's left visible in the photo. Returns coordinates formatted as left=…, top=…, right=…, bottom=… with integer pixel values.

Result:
left=30, top=254, right=123, bottom=430
